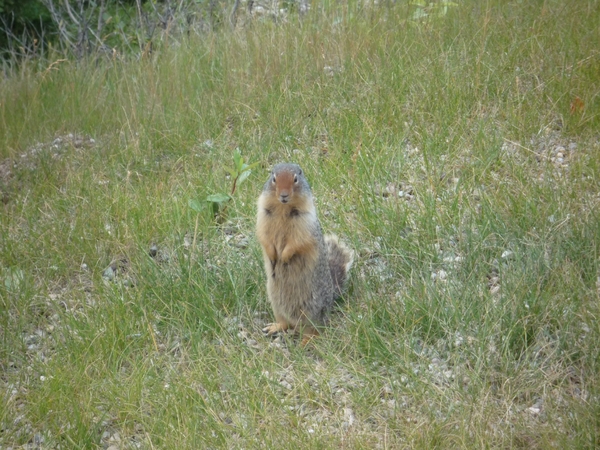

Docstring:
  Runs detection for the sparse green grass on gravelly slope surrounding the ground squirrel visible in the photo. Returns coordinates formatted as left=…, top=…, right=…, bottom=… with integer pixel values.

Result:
left=0, top=0, right=600, bottom=449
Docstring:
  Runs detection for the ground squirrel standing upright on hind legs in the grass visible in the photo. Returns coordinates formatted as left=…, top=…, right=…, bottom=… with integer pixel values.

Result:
left=256, top=164, right=353, bottom=345
